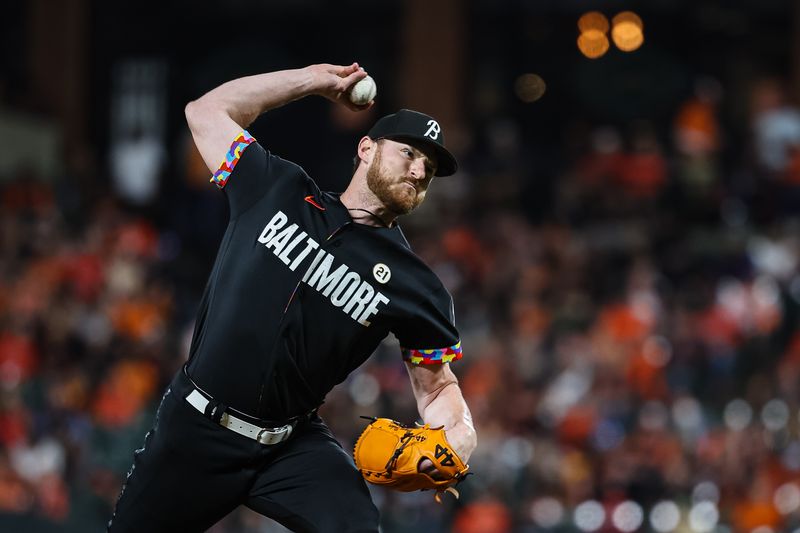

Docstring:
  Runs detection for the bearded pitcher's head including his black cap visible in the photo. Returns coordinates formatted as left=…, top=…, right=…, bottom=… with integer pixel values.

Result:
left=353, top=109, right=458, bottom=215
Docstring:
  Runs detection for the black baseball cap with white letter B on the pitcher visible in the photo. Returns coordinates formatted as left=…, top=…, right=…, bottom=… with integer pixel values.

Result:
left=367, top=109, right=458, bottom=176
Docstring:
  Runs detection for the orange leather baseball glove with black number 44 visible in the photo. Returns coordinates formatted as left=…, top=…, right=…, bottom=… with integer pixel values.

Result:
left=353, top=417, right=469, bottom=503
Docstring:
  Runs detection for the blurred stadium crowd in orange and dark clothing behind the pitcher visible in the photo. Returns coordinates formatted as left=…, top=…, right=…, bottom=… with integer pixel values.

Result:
left=0, top=58, right=800, bottom=533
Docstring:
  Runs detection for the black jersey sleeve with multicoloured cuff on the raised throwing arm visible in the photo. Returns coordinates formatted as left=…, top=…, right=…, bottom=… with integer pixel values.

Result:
left=210, top=130, right=281, bottom=218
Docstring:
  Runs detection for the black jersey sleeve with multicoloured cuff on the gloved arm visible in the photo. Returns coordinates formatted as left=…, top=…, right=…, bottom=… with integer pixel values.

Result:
left=394, top=287, right=461, bottom=365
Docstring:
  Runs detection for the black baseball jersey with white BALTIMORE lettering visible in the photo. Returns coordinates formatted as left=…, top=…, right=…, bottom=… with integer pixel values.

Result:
left=188, top=132, right=461, bottom=420
